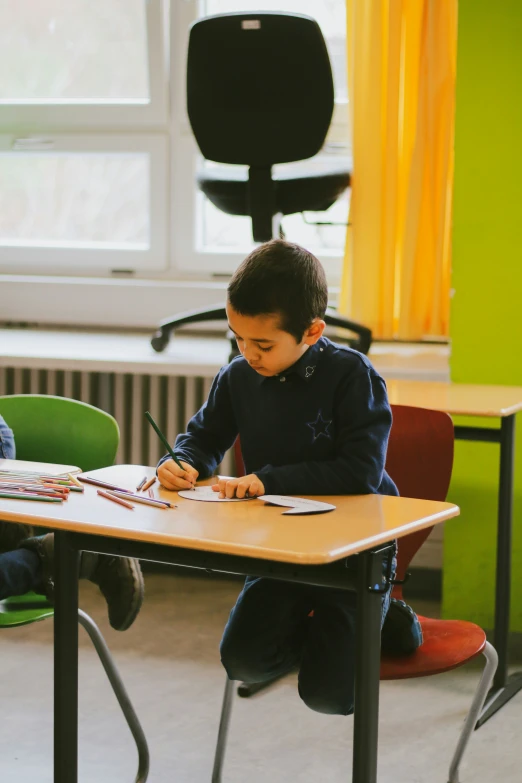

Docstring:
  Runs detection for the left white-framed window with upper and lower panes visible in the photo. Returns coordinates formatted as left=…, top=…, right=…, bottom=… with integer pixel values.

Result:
left=0, top=0, right=169, bottom=274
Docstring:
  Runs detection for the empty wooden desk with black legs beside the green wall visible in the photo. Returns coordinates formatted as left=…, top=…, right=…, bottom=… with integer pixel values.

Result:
left=387, top=381, right=522, bottom=728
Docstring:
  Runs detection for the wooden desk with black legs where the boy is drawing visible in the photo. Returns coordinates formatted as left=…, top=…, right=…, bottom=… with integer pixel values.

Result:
left=0, top=465, right=459, bottom=783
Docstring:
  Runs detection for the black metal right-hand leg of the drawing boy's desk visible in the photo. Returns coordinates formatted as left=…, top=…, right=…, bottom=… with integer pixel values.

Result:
left=352, top=552, right=384, bottom=783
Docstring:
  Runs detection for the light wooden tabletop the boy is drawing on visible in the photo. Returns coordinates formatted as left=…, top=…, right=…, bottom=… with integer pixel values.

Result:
left=0, top=465, right=459, bottom=565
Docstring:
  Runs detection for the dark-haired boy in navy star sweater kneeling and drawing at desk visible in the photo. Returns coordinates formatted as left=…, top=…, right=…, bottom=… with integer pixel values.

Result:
left=158, top=240, right=398, bottom=715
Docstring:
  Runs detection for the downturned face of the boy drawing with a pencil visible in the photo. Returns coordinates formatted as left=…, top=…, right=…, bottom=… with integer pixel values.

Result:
left=227, top=303, right=325, bottom=377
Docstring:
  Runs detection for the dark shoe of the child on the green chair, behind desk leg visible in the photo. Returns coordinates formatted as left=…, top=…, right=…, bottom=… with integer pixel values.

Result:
left=20, top=533, right=145, bottom=631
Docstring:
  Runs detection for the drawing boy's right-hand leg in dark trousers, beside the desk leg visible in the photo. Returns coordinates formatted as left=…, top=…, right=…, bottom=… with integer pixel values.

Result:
left=299, top=588, right=389, bottom=715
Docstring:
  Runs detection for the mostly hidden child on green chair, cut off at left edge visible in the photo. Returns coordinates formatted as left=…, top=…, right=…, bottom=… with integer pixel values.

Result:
left=0, top=416, right=144, bottom=631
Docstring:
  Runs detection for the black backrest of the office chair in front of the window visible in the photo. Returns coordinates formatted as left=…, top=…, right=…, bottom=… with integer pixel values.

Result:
left=187, top=13, right=334, bottom=167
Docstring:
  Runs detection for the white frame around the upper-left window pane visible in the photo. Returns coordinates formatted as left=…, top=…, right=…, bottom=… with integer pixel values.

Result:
left=0, top=0, right=167, bottom=133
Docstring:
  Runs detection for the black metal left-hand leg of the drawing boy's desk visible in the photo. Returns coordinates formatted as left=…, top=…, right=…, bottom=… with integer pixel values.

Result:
left=54, top=532, right=79, bottom=783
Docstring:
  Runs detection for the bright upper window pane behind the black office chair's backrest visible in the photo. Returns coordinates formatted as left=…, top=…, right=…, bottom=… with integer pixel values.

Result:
left=205, top=0, right=348, bottom=101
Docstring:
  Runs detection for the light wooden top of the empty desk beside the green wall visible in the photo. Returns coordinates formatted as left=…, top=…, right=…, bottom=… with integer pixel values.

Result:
left=386, top=380, right=522, bottom=417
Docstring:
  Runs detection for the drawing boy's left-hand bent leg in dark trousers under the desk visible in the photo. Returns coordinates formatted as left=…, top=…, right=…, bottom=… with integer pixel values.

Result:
left=220, top=576, right=312, bottom=682
